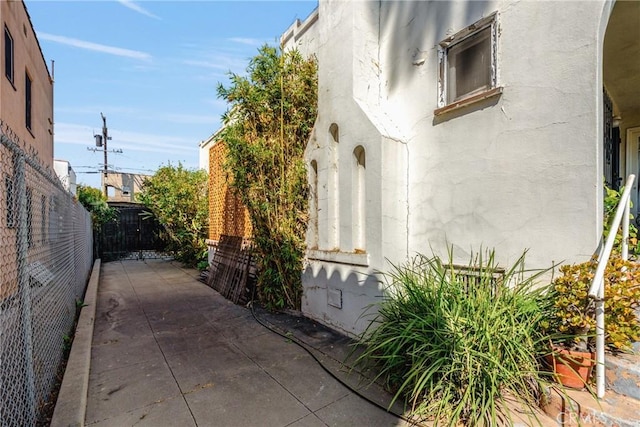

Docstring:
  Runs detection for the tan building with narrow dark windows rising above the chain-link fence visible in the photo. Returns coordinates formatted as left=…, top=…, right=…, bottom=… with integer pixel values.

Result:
left=0, top=1, right=53, bottom=168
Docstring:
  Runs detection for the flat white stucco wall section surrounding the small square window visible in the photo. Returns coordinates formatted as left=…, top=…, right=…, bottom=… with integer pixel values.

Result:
left=380, top=1, right=603, bottom=268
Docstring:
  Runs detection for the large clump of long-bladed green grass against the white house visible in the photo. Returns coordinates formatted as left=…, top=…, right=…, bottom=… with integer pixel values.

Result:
left=357, top=252, right=548, bottom=426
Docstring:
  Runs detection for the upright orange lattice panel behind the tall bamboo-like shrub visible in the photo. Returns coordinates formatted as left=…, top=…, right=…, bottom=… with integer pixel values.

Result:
left=209, top=141, right=251, bottom=241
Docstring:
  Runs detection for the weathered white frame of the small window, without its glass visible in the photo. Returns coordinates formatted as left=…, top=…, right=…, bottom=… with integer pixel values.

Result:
left=436, top=12, right=501, bottom=114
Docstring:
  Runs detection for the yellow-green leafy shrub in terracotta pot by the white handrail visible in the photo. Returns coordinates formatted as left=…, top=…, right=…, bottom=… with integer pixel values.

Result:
left=544, top=255, right=640, bottom=388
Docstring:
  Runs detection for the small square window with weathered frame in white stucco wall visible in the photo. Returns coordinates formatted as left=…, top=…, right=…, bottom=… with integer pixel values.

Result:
left=436, top=13, right=500, bottom=114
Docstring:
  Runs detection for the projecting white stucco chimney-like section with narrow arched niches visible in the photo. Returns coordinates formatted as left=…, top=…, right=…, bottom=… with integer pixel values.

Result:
left=302, top=1, right=408, bottom=334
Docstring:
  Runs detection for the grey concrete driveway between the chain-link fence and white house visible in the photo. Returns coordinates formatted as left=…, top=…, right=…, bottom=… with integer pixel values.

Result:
left=57, top=260, right=408, bottom=427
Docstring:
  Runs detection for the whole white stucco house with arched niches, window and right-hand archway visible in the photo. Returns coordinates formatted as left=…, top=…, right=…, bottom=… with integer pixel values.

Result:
left=281, top=0, right=640, bottom=340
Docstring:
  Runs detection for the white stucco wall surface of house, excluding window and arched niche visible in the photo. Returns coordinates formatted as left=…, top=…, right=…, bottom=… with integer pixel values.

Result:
left=284, top=0, right=602, bottom=333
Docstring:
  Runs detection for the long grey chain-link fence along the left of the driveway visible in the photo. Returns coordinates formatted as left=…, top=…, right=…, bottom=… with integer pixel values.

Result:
left=0, top=121, right=93, bottom=427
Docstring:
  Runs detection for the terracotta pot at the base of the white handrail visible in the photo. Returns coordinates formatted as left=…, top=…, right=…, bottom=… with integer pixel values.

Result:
left=547, top=348, right=595, bottom=389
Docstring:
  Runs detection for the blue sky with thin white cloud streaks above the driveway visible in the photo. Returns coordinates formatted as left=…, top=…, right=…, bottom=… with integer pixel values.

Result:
left=25, top=0, right=317, bottom=188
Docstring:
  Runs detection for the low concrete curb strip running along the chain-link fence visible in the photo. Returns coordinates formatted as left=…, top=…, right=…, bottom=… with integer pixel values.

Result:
left=51, top=259, right=101, bottom=427
